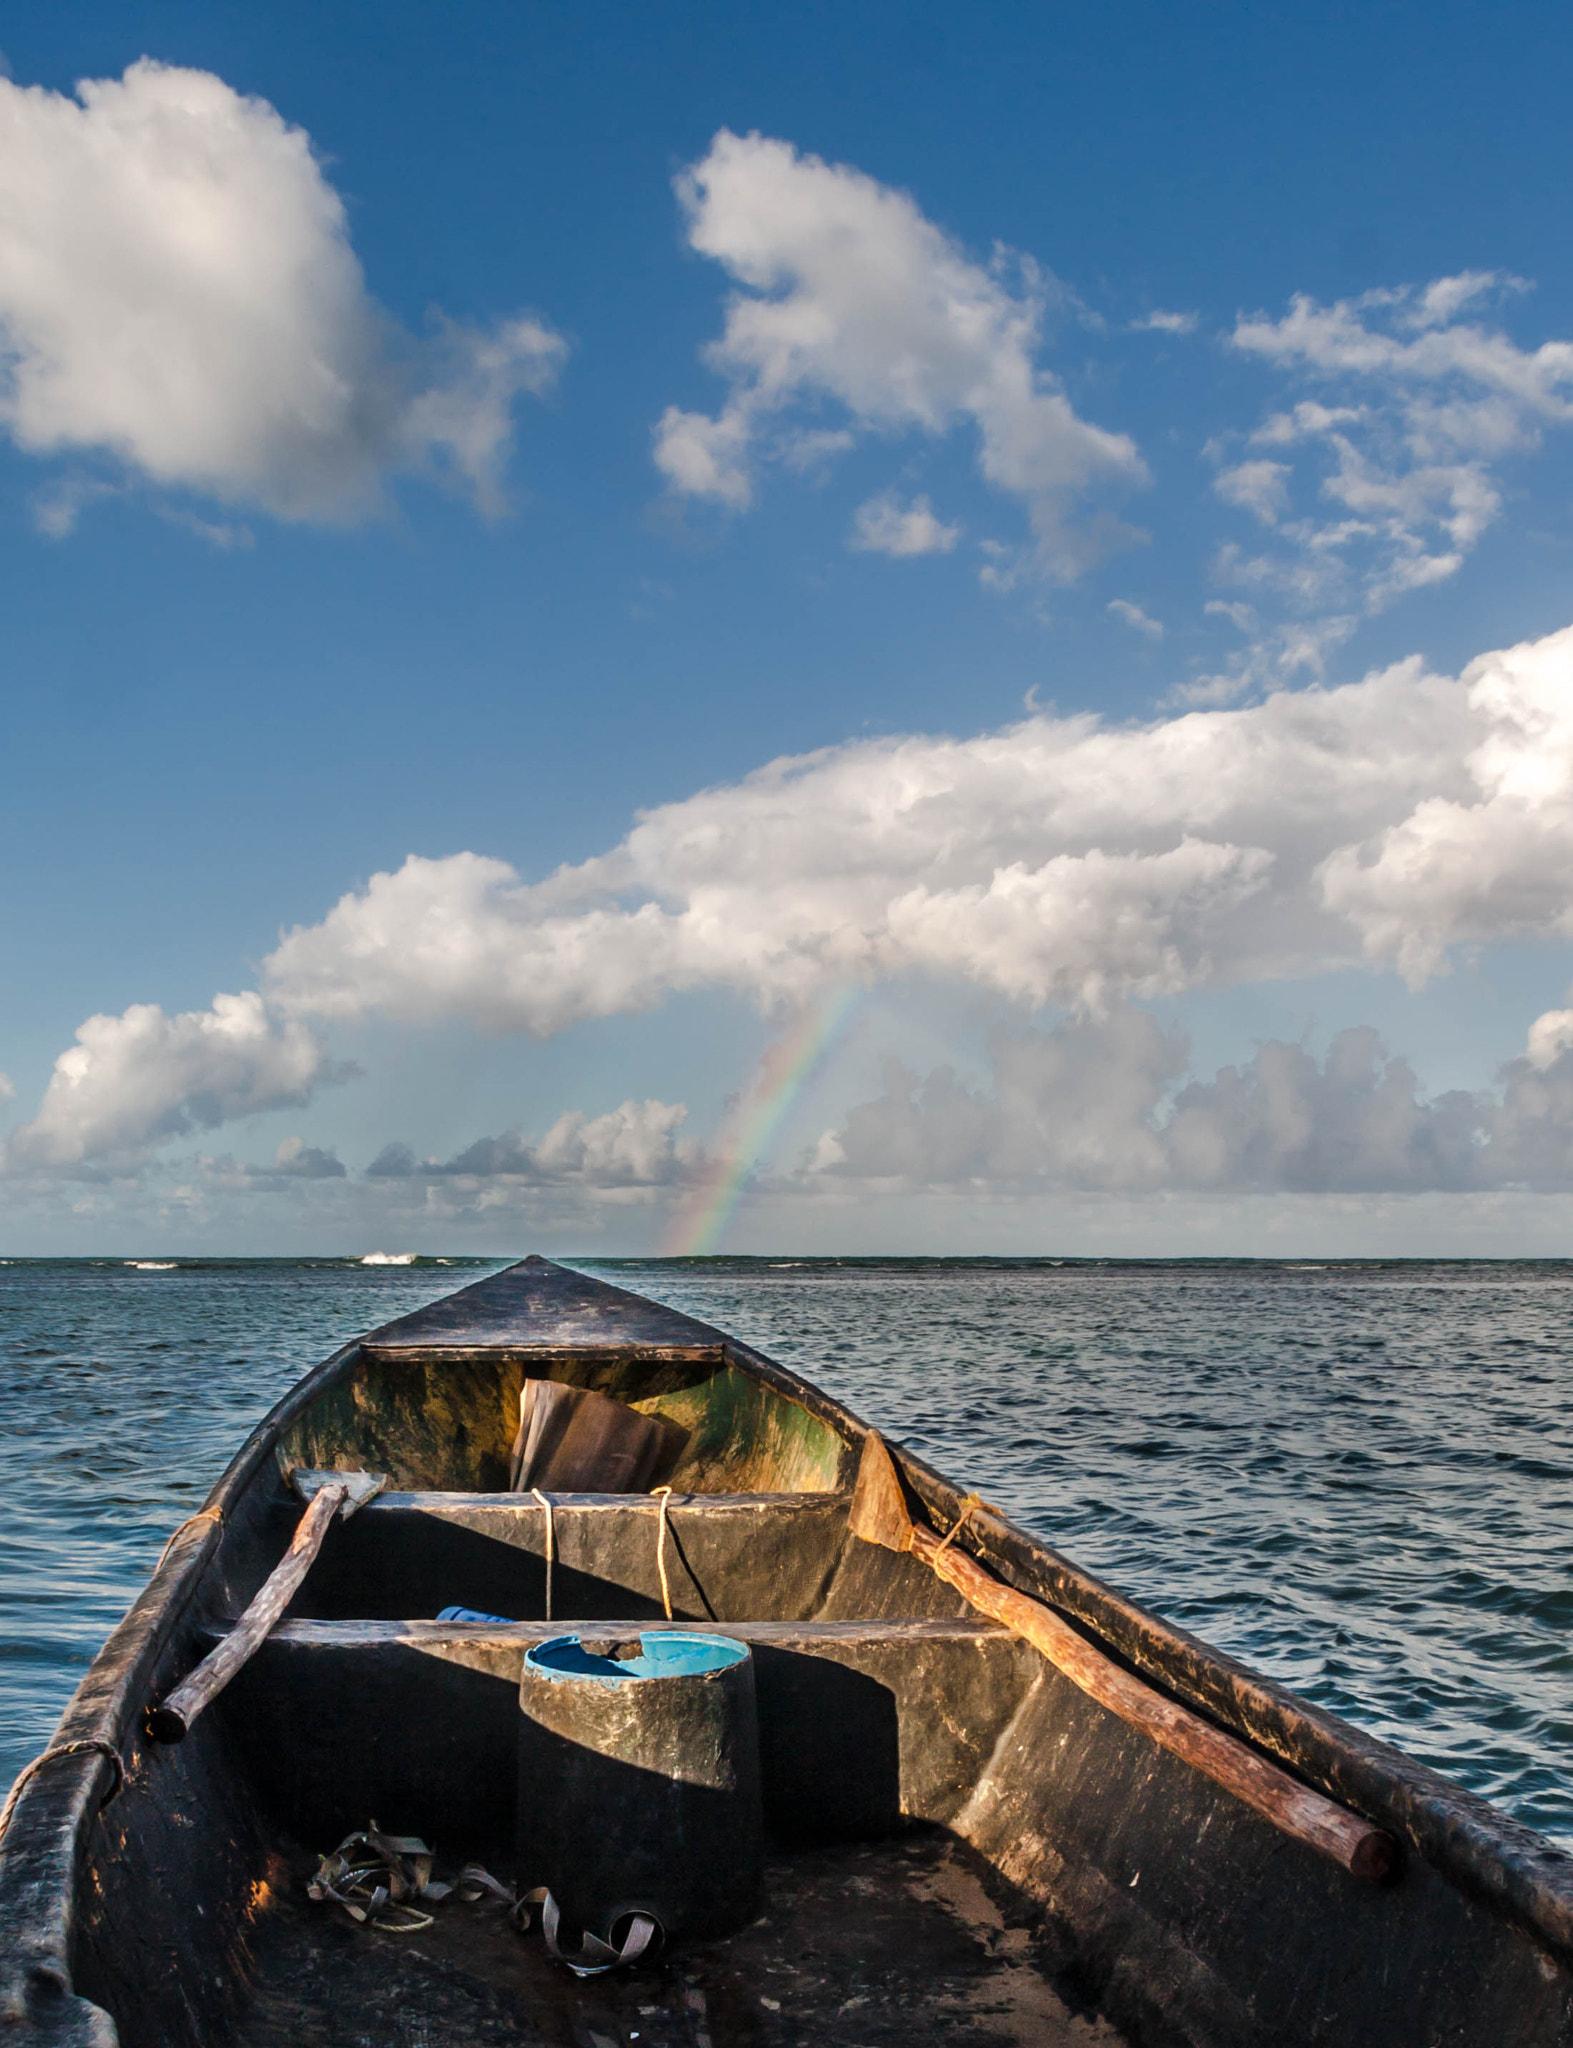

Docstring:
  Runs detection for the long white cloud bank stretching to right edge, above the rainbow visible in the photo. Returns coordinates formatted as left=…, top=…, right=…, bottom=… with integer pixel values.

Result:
left=274, top=629, right=1573, bottom=1034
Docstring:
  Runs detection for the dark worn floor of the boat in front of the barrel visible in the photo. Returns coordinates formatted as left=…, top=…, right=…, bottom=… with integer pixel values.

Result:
left=233, top=1829, right=1120, bottom=2048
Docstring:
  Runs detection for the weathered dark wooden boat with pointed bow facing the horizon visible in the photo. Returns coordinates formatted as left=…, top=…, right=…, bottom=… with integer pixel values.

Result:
left=0, top=1260, right=1573, bottom=2048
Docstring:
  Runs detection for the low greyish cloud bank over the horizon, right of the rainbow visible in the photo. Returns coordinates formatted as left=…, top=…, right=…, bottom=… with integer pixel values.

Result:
left=813, top=1010, right=1573, bottom=1194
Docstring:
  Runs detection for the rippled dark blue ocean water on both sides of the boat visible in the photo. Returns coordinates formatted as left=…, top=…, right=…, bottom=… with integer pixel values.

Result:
left=0, top=1260, right=1573, bottom=1847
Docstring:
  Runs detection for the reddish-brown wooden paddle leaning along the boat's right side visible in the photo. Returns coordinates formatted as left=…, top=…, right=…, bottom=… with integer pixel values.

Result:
left=850, top=1430, right=1399, bottom=1882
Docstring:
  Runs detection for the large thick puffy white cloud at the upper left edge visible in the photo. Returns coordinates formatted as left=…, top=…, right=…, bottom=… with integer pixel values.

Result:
left=0, top=59, right=565, bottom=532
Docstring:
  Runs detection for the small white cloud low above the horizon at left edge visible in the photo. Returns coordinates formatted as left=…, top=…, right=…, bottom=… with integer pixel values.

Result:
left=4, top=991, right=338, bottom=1174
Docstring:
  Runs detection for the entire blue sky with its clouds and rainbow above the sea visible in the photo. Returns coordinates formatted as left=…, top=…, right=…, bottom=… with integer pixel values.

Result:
left=0, top=6, right=1573, bottom=1253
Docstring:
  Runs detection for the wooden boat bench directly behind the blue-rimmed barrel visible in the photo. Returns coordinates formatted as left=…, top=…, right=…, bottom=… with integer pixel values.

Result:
left=211, top=1613, right=1045, bottom=1853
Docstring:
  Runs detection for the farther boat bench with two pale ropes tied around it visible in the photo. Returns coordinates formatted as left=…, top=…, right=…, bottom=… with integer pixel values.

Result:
left=279, top=1493, right=965, bottom=1622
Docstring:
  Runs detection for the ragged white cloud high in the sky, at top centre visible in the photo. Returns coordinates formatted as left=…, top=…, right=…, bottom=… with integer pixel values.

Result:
left=655, top=129, right=1147, bottom=575
